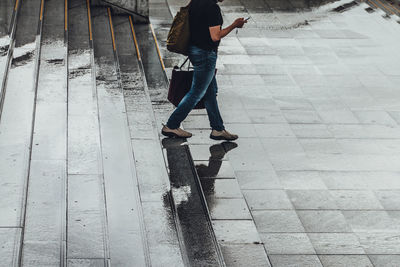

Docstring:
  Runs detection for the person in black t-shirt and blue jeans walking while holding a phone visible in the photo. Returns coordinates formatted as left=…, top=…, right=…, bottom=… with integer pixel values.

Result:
left=162, top=0, right=247, bottom=141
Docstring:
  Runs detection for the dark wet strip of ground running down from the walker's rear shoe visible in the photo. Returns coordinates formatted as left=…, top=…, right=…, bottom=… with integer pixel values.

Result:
left=163, top=138, right=224, bottom=266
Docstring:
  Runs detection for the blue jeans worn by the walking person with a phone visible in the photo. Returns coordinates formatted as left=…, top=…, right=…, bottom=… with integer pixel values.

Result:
left=167, top=45, right=225, bottom=131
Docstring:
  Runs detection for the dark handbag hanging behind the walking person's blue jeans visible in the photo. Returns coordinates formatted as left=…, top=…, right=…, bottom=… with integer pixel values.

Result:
left=168, top=58, right=205, bottom=109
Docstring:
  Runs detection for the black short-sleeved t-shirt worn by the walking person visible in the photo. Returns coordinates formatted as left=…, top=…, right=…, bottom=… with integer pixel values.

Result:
left=189, top=0, right=223, bottom=51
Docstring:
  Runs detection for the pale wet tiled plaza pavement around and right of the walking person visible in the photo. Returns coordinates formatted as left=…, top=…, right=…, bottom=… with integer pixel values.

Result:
left=157, top=0, right=400, bottom=267
